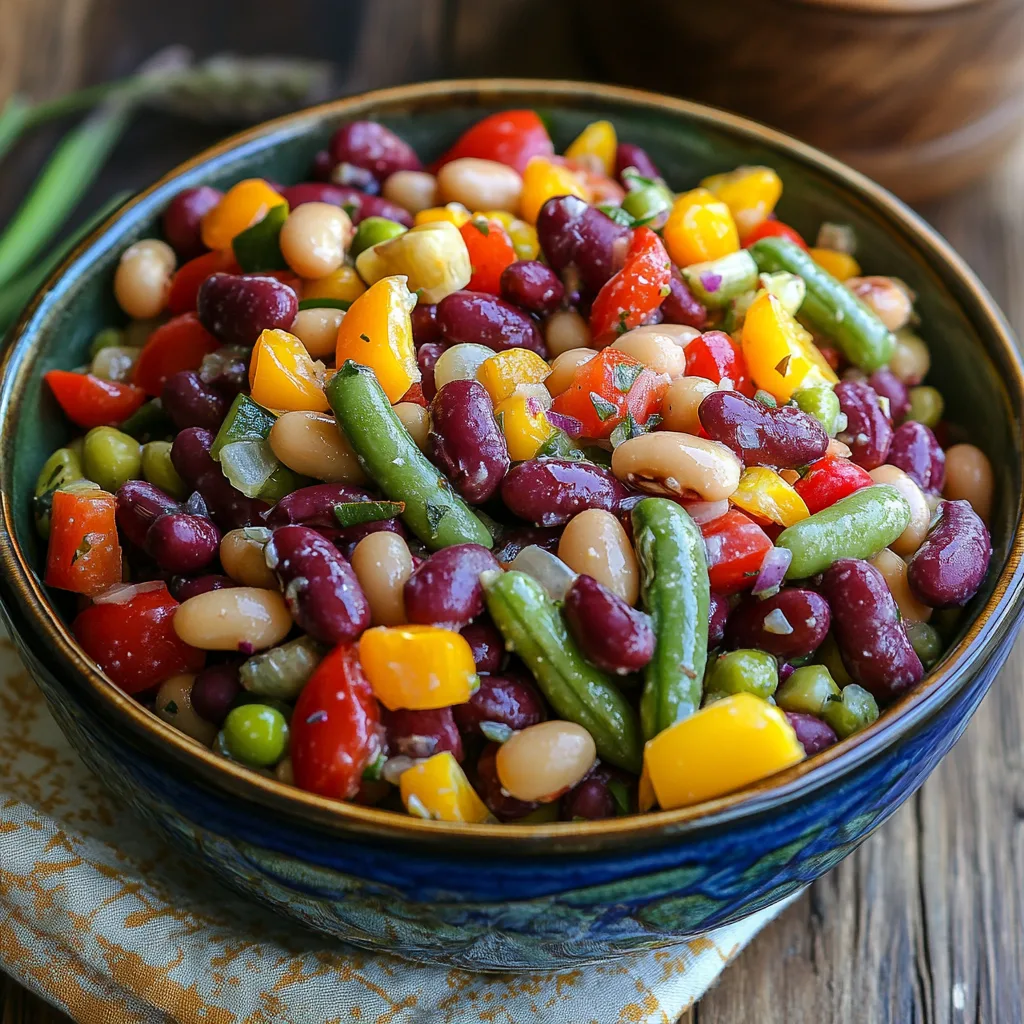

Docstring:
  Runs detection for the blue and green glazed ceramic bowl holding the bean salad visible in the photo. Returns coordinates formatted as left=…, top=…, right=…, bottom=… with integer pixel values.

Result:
left=0, top=81, right=1024, bottom=970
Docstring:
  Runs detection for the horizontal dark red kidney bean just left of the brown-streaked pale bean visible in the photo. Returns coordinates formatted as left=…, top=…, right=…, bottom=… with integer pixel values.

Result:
left=502, top=459, right=629, bottom=526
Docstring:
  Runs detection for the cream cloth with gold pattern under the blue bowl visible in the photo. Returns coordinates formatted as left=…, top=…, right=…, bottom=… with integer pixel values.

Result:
left=0, top=632, right=781, bottom=1024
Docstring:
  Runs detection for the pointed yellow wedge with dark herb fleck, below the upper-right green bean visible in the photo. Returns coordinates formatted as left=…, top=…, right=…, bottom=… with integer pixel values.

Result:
left=742, top=293, right=839, bottom=402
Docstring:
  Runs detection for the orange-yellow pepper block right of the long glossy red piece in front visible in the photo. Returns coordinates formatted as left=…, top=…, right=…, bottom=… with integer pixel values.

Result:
left=359, top=626, right=479, bottom=711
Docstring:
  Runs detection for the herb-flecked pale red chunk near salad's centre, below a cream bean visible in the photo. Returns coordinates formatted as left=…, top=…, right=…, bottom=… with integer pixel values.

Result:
left=551, top=348, right=669, bottom=437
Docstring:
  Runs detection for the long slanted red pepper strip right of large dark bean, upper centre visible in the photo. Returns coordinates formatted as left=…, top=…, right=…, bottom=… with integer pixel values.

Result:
left=590, top=227, right=672, bottom=348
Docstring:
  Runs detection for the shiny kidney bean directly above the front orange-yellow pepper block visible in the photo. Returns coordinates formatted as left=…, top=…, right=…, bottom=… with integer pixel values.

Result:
left=404, top=544, right=501, bottom=627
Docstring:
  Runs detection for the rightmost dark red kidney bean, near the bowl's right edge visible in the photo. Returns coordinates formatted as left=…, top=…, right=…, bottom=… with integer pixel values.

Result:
left=906, top=501, right=992, bottom=608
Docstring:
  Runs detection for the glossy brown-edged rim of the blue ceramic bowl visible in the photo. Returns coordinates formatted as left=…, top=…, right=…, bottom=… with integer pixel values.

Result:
left=0, top=78, right=1024, bottom=856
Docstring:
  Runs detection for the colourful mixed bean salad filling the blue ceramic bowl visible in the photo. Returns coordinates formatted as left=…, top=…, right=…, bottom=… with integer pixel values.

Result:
left=34, top=111, right=993, bottom=823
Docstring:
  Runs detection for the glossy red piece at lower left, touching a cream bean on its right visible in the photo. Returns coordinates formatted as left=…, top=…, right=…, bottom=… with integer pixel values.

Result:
left=71, top=585, right=206, bottom=693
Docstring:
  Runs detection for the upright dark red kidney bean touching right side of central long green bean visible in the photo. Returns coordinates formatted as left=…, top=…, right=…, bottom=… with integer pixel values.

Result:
left=427, top=380, right=511, bottom=505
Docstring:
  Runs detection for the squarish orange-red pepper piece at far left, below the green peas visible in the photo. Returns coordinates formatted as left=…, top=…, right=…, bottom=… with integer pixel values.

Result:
left=44, top=488, right=121, bottom=597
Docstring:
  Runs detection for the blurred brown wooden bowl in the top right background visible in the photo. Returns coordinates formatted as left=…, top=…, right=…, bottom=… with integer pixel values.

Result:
left=584, top=0, right=1024, bottom=202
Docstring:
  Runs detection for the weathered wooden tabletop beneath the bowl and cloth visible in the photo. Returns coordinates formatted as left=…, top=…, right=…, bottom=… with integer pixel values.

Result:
left=0, top=0, right=1024, bottom=1024
